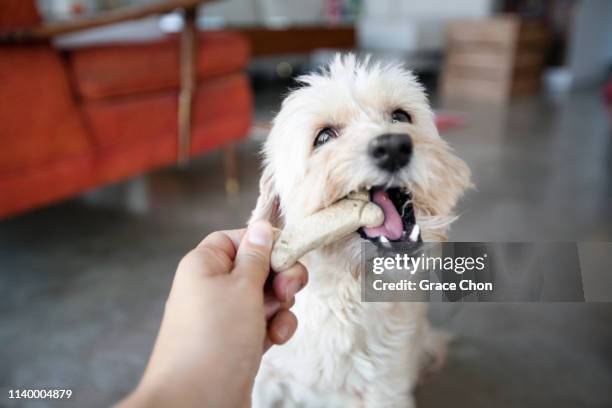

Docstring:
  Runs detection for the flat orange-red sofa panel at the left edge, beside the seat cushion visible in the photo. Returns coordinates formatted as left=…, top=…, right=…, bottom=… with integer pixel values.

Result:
left=0, top=45, right=91, bottom=174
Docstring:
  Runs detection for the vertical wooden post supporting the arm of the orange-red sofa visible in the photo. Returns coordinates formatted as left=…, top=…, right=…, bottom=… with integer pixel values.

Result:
left=177, top=7, right=198, bottom=165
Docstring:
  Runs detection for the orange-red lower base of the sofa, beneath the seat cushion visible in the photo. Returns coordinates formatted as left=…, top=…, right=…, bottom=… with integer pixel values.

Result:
left=0, top=74, right=251, bottom=217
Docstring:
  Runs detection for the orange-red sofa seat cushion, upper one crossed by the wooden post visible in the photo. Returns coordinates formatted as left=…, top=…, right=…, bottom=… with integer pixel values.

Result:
left=68, top=31, right=249, bottom=100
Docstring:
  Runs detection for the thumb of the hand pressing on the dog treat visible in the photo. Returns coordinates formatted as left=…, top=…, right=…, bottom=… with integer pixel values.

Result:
left=232, top=220, right=273, bottom=287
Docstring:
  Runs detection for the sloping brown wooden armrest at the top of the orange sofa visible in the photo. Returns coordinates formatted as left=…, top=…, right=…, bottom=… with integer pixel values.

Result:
left=0, top=0, right=214, bottom=44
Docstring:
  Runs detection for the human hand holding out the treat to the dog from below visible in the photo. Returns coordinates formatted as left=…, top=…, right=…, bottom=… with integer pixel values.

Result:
left=119, top=221, right=307, bottom=407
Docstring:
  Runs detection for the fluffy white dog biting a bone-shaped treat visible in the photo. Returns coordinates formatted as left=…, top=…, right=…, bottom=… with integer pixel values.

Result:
left=250, top=54, right=471, bottom=407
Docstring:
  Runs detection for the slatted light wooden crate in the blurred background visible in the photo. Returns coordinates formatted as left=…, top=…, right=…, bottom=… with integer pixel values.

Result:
left=442, top=15, right=548, bottom=102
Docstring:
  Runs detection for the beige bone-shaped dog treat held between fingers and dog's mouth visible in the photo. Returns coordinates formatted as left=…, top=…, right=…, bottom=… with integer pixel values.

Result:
left=271, top=192, right=384, bottom=272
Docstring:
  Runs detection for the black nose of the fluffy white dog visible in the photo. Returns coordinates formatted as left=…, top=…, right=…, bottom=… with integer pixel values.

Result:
left=368, top=133, right=412, bottom=172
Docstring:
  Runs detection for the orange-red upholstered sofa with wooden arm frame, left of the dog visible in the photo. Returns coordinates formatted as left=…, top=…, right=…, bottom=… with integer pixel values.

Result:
left=0, top=0, right=252, bottom=218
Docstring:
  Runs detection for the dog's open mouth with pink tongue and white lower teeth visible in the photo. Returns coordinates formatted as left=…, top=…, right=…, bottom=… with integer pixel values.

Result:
left=358, top=187, right=421, bottom=243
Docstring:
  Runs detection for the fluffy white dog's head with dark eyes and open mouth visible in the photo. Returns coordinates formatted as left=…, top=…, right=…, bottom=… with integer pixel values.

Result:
left=252, top=55, right=470, bottom=250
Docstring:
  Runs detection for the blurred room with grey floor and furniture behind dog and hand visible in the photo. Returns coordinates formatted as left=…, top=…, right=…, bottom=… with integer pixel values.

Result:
left=0, top=0, right=612, bottom=407
